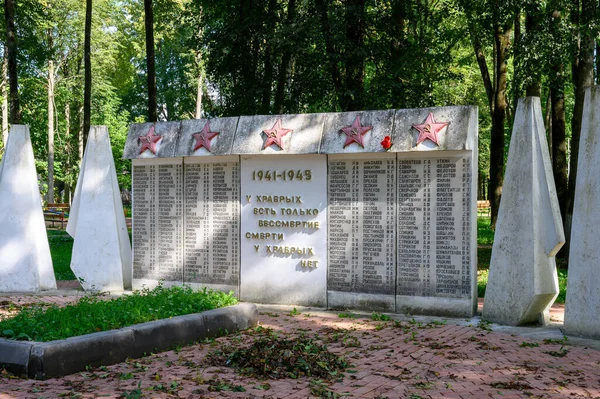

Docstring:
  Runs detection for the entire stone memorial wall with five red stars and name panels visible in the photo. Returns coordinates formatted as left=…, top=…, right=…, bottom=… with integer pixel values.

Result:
left=124, top=107, right=477, bottom=316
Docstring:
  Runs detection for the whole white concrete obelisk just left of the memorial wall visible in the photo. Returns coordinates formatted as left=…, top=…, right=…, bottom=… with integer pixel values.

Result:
left=67, top=126, right=132, bottom=291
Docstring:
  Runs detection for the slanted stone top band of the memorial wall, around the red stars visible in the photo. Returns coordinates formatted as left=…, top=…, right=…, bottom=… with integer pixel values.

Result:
left=123, top=105, right=477, bottom=159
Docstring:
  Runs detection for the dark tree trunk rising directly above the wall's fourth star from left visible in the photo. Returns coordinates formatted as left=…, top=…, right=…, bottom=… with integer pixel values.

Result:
left=342, top=0, right=365, bottom=111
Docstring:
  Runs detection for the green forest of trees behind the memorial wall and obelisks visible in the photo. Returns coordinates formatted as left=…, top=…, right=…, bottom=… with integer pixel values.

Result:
left=0, top=0, right=600, bottom=260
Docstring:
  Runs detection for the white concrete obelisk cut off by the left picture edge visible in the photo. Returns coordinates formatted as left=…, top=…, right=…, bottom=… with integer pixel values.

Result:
left=0, top=125, right=56, bottom=292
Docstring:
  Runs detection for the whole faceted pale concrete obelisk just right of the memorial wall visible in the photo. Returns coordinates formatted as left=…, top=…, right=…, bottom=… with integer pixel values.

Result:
left=483, top=97, right=565, bottom=325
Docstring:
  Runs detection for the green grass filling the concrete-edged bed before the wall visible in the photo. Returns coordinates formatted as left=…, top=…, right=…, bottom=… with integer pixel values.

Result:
left=0, top=286, right=237, bottom=342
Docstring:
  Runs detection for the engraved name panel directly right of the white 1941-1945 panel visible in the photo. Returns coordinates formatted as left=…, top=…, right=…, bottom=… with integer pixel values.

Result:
left=327, top=153, right=396, bottom=311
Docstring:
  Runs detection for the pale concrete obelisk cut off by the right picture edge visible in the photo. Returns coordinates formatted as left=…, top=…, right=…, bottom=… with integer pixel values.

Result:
left=565, top=86, right=600, bottom=339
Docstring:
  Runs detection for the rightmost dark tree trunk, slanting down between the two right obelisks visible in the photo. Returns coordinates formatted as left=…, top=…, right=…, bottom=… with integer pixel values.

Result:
left=564, top=0, right=596, bottom=255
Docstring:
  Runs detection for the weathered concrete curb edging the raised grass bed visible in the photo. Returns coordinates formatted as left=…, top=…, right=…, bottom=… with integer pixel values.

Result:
left=0, top=303, right=258, bottom=379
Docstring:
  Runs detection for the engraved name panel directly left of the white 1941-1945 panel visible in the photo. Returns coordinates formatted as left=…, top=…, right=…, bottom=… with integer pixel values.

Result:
left=183, top=156, right=240, bottom=292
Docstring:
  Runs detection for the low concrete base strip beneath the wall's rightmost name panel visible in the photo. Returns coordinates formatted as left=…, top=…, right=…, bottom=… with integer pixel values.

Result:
left=396, top=295, right=477, bottom=317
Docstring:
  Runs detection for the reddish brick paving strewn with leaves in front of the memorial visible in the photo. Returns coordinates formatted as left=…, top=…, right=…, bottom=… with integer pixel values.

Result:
left=0, top=297, right=600, bottom=399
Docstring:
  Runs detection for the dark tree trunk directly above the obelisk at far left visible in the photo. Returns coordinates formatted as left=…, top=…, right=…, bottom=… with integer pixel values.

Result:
left=4, top=0, right=21, bottom=125
